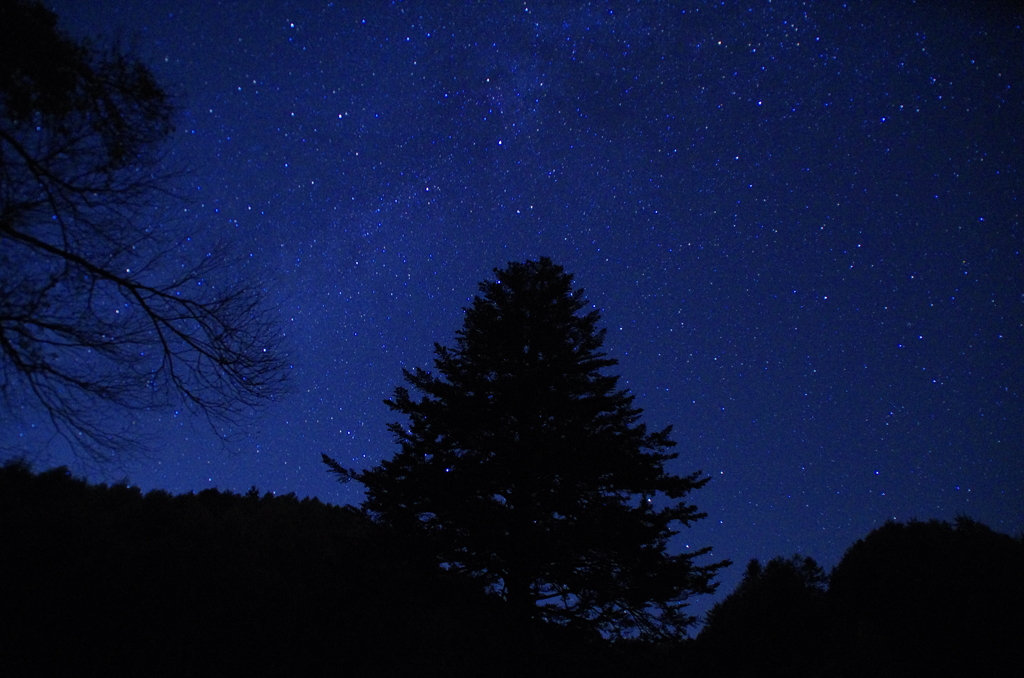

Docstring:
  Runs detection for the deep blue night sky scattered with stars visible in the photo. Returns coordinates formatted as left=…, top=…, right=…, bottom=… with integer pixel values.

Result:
left=39, top=0, right=1024, bottom=614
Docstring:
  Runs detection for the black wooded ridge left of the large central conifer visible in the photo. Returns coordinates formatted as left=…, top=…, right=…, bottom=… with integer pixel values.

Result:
left=0, top=464, right=598, bottom=676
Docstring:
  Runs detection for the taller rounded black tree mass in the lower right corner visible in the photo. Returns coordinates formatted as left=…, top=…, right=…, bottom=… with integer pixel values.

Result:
left=828, top=516, right=1024, bottom=676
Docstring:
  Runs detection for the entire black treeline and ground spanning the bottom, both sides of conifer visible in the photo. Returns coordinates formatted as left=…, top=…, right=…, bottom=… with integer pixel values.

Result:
left=0, top=464, right=1024, bottom=676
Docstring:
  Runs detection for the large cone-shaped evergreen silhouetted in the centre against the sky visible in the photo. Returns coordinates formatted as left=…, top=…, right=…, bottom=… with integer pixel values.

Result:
left=325, top=258, right=725, bottom=636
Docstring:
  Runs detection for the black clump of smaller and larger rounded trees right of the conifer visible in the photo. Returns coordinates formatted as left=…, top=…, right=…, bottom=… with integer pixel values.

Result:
left=689, top=517, right=1024, bottom=677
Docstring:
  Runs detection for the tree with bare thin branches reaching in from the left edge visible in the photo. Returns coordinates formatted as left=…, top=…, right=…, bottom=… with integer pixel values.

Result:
left=0, top=0, right=285, bottom=462
